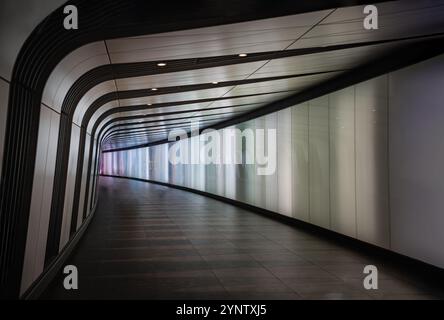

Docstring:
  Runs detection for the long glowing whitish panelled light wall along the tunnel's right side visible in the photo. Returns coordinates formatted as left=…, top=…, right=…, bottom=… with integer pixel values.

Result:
left=101, top=56, right=444, bottom=267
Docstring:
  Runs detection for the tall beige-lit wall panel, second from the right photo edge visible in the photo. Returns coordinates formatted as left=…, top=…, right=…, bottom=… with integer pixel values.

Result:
left=355, top=76, right=390, bottom=248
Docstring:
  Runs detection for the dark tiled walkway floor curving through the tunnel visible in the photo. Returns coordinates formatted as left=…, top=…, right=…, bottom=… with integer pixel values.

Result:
left=43, top=177, right=444, bottom=299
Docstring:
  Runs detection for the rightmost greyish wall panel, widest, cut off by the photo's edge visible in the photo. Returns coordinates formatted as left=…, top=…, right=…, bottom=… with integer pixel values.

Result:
left=389, top=55, right=444, bottom=268
